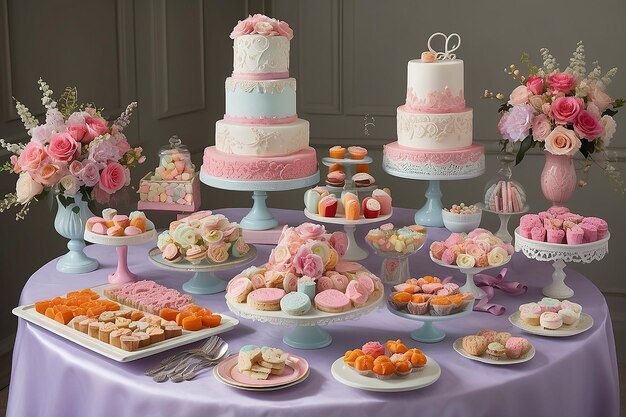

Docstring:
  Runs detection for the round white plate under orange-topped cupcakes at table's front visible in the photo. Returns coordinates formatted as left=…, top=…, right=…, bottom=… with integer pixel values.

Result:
left=330, top=356, right=441, bottom=392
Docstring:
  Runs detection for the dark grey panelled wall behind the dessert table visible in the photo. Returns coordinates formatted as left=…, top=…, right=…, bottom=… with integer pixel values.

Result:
left=0, top=0, right=626, bottom=370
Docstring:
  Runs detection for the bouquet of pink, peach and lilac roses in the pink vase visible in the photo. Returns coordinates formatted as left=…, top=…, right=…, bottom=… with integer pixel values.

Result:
left=483, top=42, right=624, bottom=192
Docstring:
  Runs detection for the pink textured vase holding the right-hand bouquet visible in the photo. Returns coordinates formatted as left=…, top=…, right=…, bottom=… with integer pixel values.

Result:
left=541, top=152, right=576, bottom=206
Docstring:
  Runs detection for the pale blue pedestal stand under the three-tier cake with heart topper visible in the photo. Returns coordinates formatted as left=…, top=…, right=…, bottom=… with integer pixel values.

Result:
left=383, top=164, right=485, bottom=227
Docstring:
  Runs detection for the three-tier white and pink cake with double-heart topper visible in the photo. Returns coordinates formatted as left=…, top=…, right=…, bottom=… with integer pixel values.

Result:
left=383, top=34, right=485, bottom=179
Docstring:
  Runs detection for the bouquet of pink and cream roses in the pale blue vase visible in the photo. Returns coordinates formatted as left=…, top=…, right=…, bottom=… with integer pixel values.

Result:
left=0, top=79, right=145, bottom=219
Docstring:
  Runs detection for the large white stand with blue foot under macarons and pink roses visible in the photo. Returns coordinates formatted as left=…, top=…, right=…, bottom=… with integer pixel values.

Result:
left=226, top=292, right=385, bottom=349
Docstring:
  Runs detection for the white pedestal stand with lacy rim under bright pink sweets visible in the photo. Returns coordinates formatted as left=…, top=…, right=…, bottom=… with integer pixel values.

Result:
left=515, top=228, right=611, bottom=299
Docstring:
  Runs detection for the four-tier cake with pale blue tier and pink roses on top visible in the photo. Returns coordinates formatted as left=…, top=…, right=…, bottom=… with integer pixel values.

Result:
left=202, top=15, right=317, bottom=181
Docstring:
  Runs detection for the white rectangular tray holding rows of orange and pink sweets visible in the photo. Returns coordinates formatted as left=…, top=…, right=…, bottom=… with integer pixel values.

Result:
left=13, top=286, right=239, bottom=362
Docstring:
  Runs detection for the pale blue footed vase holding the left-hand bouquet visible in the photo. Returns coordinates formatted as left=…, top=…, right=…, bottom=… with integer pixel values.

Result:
left=54, top=193, right=98, bottom=274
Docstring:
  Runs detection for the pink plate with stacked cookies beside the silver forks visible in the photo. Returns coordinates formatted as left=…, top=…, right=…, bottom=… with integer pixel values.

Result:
left=214, top=354, right=309, bottom=389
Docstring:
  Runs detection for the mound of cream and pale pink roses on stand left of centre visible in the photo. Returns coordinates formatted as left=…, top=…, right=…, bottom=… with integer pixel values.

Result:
left=157, top=210, right=250, bottom=264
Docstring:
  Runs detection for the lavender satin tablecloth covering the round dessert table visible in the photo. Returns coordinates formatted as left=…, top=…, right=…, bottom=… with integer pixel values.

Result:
left=7, top=209, right=619, bottom=417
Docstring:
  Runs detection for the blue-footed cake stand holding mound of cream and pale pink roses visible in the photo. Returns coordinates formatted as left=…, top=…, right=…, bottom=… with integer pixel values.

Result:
left=148, top=245, right=257, bottom=294
